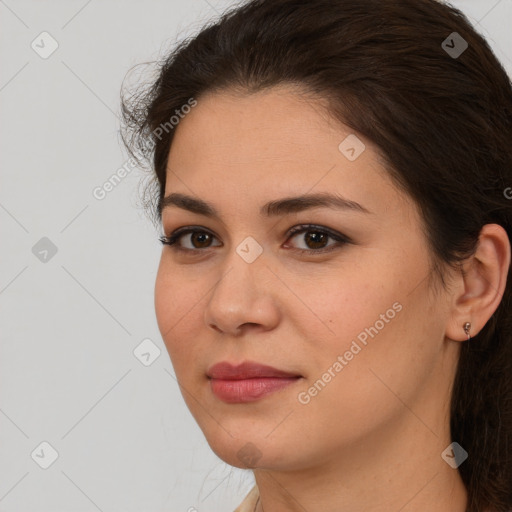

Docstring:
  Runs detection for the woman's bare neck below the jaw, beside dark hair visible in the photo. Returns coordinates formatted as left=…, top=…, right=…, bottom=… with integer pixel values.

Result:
left=254, top=410, right=467, bottom=512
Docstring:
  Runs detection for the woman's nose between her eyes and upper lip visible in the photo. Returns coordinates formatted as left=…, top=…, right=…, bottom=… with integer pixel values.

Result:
left=204, top=249, right=280, bottom=337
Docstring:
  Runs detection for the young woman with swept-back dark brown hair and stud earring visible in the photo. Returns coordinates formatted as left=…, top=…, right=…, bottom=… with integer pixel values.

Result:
left=123, top=0, right=512, bottom=512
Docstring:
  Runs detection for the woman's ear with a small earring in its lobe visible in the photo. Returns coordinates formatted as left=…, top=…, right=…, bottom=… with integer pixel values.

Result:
left=445, top=224, right=511, bottom=341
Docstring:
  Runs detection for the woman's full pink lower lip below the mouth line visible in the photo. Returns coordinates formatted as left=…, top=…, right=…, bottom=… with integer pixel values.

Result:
left=210, top=377, right=300, bottom=404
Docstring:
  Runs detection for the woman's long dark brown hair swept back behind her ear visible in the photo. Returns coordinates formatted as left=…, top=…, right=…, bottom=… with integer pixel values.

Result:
left=122, top=0, right=512, bottom=512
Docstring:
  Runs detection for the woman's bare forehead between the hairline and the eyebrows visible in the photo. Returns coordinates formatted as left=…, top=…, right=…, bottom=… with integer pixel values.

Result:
left=165, top=86, right=416, bottom=226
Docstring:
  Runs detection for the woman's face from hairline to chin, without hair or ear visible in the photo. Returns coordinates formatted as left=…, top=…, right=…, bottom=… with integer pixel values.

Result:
left=155, top=86, right=458, bottom=469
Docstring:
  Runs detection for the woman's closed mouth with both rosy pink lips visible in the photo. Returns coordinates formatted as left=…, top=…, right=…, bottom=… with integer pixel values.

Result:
left=207, top=361, right=303, bottom=403
